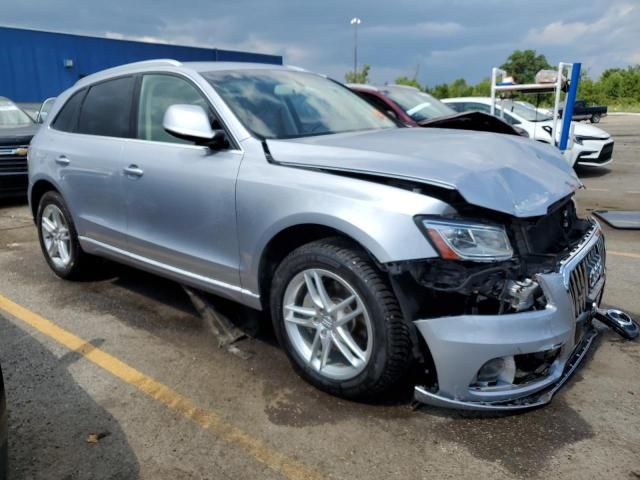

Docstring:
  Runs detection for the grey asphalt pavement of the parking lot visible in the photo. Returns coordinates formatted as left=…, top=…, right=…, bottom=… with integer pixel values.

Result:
left=0, top=116, right=640, bottom=480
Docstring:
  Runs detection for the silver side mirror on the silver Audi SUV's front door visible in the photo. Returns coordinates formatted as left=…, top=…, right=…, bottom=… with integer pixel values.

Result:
left=162, top=104, right=226, bottom=148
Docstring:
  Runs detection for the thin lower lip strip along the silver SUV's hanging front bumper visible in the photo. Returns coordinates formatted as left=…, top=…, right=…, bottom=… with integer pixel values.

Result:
left=414, top=327, right=598, bottom=412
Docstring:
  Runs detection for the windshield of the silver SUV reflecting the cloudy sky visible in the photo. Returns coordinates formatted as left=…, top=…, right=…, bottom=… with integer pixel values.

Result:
left=202, top=69, right=396, bottom=138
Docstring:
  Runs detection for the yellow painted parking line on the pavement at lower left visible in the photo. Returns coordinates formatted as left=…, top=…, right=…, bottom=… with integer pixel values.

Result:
left=0, top=295, right=322, bottom=480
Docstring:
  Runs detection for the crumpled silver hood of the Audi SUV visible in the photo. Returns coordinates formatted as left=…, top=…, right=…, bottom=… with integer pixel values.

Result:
left=267, top=128, right=581, bottom=217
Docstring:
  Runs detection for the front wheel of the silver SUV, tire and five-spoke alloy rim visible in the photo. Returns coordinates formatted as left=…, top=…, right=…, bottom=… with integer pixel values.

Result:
left=270, top=237, right=412, bottom=400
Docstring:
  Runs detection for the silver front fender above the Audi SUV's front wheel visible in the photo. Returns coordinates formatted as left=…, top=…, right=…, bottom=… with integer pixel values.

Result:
left=237, top=160, right=453, bottom=304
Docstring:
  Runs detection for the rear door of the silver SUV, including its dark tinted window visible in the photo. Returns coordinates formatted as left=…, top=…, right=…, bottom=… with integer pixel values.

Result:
left=48, top=76, right=134, bottom=248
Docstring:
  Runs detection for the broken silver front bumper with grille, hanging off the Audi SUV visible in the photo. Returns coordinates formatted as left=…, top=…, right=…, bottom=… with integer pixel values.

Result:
left=414, top=224, right=605, bottom=411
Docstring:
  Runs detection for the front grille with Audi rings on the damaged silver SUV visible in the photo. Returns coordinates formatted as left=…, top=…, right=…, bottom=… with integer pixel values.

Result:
left=569, top=236, right=606, bottom=318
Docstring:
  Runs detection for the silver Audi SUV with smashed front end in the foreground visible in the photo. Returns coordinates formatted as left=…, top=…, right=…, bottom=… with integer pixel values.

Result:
left=29, top=60, right=605, bottom=409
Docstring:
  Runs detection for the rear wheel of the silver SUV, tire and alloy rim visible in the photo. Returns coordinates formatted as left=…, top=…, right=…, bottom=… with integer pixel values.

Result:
left=36, top=191, right=94, bottom=280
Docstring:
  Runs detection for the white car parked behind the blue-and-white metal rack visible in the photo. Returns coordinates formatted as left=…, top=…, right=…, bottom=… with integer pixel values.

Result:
left=442, top=97, right=613, bottom=167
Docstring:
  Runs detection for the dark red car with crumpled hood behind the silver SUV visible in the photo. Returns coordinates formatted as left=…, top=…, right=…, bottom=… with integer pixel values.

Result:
left=347, top=84, right=529, bottom=137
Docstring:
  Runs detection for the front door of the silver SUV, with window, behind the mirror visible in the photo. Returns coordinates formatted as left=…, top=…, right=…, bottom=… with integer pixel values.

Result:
left=121, top=73, right=242, bottom=298
